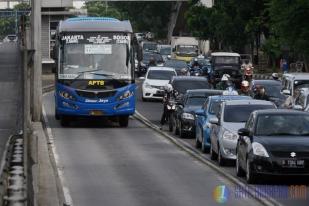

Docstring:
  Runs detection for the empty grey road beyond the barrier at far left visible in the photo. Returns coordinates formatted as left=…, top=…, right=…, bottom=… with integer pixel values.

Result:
left=0, top=43, right=22, bottom=158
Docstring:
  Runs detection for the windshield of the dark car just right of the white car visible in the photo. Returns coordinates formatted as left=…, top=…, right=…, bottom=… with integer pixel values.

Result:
left=173, top=79, right=210, bottom=94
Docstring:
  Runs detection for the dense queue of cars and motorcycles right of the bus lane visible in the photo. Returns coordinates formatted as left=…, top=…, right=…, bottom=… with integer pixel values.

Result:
left=138, top=48, right=309, bottom=183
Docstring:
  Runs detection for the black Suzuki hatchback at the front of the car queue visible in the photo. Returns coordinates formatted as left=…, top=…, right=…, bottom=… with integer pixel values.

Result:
left=236, top=109, right=309, bottom=183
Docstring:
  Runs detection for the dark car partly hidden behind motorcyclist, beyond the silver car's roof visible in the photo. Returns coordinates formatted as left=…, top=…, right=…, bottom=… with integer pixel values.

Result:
left=251, top=80, right=286, bottom=108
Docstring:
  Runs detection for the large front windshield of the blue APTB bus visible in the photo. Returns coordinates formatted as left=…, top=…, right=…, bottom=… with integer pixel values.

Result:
left=58, top=32, right=131, bottom=79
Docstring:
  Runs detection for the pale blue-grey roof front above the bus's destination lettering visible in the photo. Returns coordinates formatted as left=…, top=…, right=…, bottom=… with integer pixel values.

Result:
left=58, top=17, right=133, bottom=33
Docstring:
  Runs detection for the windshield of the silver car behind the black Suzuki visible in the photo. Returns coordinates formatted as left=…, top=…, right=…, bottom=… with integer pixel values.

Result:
left=223, top=104, right=275, bottom=122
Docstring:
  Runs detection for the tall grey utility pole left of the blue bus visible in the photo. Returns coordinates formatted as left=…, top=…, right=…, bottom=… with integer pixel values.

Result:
left=31, top=0, right=42, bottom=122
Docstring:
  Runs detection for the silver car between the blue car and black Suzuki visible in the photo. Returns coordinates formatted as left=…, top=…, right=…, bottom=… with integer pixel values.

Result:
left=209, top=99, right=276, bottom=166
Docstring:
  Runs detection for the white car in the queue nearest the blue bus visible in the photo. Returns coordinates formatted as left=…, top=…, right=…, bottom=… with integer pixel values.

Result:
left=142, top=67, right=177, bottom=101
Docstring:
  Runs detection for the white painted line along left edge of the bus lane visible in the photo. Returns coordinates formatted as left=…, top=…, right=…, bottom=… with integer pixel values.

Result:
left=42, top=105, right=73, bottom=206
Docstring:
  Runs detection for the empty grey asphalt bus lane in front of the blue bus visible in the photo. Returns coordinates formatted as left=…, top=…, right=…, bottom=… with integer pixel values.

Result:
left=43, top=93, right=259, bottom=206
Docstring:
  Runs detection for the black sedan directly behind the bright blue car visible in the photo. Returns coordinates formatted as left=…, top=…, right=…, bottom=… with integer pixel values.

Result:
left=175, top=89, right=223, bottom=138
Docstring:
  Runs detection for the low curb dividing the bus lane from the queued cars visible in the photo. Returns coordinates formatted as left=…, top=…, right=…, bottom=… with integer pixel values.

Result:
left=134, top=111, right=282, bottom=206
